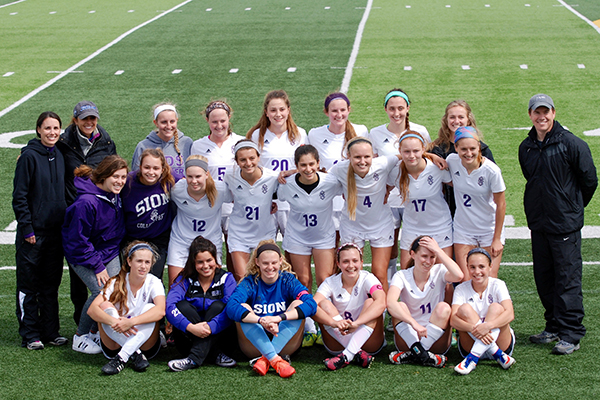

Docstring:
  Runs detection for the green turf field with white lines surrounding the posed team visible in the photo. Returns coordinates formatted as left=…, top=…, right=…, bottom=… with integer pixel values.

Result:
left=0, top=0, right=600, bottom=399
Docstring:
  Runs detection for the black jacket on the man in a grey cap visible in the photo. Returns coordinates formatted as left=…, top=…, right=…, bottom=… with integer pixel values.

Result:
left=519, top=121, right=598, bottom=234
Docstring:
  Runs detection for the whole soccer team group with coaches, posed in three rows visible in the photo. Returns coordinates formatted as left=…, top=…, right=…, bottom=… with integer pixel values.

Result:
left=12, top=84, right=598, bottom=378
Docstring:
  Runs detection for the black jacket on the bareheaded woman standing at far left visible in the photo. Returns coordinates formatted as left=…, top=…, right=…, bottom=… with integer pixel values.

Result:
left=12, top=139, right=67, bottom=236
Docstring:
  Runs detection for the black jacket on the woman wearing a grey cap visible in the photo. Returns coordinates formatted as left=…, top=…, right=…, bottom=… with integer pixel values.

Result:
left=56, top=124, right=117, bottom=205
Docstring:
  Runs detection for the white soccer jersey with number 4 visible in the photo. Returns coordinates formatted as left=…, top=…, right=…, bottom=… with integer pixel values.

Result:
left=330, top=156, right=398, bottom=233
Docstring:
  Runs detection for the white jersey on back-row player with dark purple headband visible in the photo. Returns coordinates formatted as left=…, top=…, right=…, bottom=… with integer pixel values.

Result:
left=306, top=124, right=368, bottom=171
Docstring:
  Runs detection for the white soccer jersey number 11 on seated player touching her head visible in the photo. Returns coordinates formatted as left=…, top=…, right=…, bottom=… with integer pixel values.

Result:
left=390, top=264, right=448, bottom=326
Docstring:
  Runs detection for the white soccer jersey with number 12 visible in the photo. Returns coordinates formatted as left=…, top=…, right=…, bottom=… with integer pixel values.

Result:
left=170, top=179, right=232, bottom=249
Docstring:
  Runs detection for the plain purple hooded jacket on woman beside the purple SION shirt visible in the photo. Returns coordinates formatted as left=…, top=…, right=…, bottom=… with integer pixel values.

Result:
left=62, top=177, right=125, bottom=274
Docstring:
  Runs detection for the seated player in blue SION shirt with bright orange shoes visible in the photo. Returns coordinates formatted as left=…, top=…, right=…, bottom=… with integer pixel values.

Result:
left=226, top=239, right=317, bottom=378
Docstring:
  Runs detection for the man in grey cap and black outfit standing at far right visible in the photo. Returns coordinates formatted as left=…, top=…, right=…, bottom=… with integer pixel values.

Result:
left=519, top=94, right=598, bottom=354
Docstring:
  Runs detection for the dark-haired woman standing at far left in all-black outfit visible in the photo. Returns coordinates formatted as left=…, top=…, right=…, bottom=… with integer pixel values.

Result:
left=13, top=111, right=67, bottom=350
